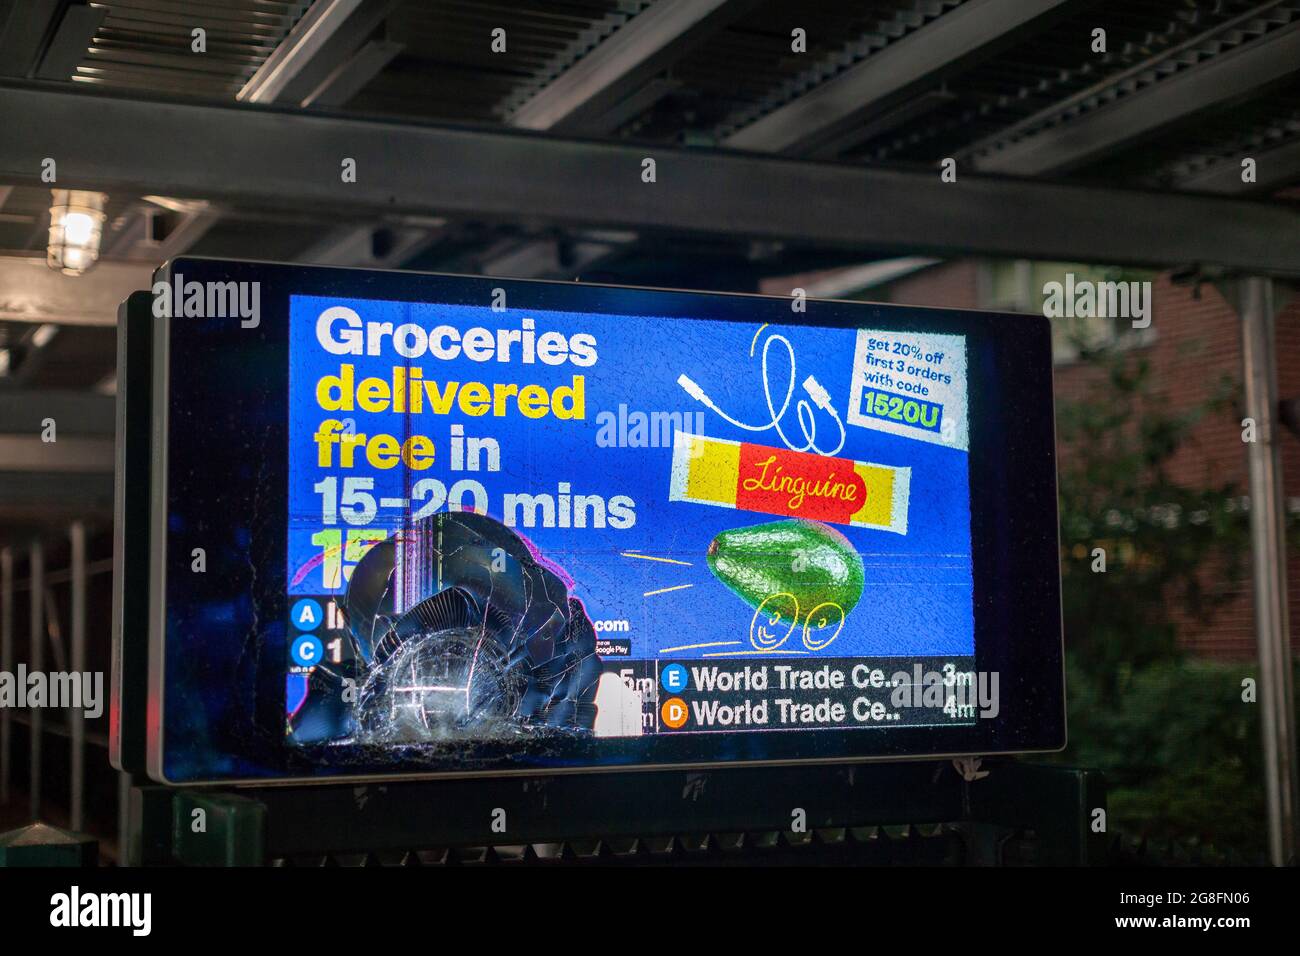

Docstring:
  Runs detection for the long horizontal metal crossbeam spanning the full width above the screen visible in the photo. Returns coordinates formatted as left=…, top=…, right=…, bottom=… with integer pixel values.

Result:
left=0, top=83, right=1300, bottom=281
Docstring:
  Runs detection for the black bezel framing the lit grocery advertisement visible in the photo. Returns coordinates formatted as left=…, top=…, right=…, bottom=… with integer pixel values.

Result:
left=148, top=259, right=1065, bottom=783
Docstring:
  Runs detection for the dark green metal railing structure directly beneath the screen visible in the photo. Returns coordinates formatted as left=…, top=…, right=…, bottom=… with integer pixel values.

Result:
left=114, top=760, right=1108, bottom=866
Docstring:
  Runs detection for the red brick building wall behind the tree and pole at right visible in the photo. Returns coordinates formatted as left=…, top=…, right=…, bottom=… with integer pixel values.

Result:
left=863, top=260, right=1300, bottom=658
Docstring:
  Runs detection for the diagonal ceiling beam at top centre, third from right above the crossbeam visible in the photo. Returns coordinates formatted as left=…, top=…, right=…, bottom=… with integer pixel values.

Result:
left=508, top=0, right=757, bottom=130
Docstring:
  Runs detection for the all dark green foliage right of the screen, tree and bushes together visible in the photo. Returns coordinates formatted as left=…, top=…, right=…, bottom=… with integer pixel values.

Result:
left=1057, top=351, right=1265, bottom=855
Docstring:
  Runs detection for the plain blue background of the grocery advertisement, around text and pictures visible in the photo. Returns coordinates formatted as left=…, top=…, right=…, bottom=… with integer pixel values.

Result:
left=287, top=297, right=974, bottom=658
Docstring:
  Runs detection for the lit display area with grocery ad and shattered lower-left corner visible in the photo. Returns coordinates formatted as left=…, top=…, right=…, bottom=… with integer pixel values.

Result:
left=285, top=295, right=975, bottom=747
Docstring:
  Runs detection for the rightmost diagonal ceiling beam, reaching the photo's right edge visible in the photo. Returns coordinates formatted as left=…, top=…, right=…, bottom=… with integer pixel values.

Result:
left=974, top=21, right=1300, bottom=176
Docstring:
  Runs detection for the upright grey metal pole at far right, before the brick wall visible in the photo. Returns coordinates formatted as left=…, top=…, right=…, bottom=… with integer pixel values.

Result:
left=1238, top=277, right=1296, bottom=866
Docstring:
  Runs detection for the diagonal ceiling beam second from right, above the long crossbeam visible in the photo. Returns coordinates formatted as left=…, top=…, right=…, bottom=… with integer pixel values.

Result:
left=725, top=0, right=1071, bottom=152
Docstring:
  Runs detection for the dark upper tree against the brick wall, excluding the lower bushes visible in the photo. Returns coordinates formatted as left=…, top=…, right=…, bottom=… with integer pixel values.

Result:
left=1057, top=352, right=1247, bottom=702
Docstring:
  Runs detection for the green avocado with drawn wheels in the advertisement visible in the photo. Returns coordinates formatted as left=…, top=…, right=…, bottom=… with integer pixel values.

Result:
left=707, top=518, right=865, bottom=620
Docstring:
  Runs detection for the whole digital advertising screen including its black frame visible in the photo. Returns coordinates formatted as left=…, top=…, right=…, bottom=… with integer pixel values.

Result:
left=142, top=259, right=1063, bottom=782
